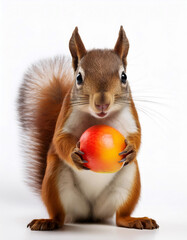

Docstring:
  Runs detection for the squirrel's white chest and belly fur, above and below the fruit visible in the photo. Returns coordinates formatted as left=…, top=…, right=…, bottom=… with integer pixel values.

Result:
left=58, top=108, right=137, bottom=221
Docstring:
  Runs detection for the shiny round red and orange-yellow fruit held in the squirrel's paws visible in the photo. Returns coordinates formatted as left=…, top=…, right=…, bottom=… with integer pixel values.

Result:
left=80, top=125, right=125, bottom=173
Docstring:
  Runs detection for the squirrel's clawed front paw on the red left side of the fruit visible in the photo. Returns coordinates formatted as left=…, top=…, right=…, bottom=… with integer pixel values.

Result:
left=71, top=142, right=89, bottom=170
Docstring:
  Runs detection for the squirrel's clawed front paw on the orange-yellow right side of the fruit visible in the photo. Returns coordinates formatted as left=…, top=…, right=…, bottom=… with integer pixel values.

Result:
left=119, top=139, right=136, bottom=166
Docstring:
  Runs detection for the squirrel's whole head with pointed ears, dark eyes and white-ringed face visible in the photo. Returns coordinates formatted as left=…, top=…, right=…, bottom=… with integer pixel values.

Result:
left=69, top=26, right=131, bottom=118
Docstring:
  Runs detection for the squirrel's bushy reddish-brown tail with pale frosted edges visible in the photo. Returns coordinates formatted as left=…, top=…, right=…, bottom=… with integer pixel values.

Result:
left=18, top=57, right=73, bottom=192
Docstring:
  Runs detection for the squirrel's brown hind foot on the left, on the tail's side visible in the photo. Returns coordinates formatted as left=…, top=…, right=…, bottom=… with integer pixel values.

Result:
left=27, top=219, right=63, bottom=231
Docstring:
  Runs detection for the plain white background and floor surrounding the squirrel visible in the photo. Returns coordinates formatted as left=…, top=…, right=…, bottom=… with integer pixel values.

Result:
left=0, top=0, right=187, bottom=240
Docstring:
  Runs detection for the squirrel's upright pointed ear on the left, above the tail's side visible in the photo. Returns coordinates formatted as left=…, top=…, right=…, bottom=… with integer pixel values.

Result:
left=69, top=27, right=87, bottom=70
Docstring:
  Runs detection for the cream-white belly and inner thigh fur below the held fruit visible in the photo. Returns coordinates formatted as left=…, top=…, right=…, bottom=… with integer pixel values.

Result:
left=58, top=159, right=137, bottom=221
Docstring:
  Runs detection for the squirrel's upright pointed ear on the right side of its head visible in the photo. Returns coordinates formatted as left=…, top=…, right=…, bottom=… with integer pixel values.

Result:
left=114, top=26, right=129, bottom=62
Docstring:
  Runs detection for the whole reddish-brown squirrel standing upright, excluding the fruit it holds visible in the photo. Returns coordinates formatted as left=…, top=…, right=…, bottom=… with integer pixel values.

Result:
left=18, top=26, right=158, bottom=230
